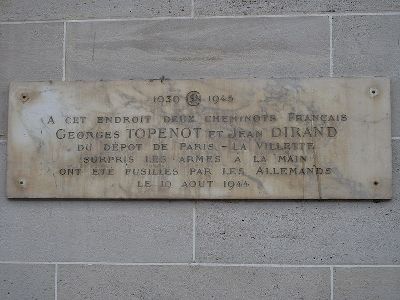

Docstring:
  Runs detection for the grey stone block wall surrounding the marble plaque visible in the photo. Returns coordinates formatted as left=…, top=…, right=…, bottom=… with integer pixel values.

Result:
left=0, top=0, right=400, bottom=300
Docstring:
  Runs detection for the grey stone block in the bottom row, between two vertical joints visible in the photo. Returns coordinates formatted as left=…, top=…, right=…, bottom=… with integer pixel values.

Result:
left=58, top=265, right=330, bottom=300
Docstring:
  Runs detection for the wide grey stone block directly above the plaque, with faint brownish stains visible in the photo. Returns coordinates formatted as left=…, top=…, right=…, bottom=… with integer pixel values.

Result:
left=66, top=17, right=329, bottom=80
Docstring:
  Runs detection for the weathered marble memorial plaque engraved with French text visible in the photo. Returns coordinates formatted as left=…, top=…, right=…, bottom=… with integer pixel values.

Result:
left=7, top=78, right=392, bottom=199
